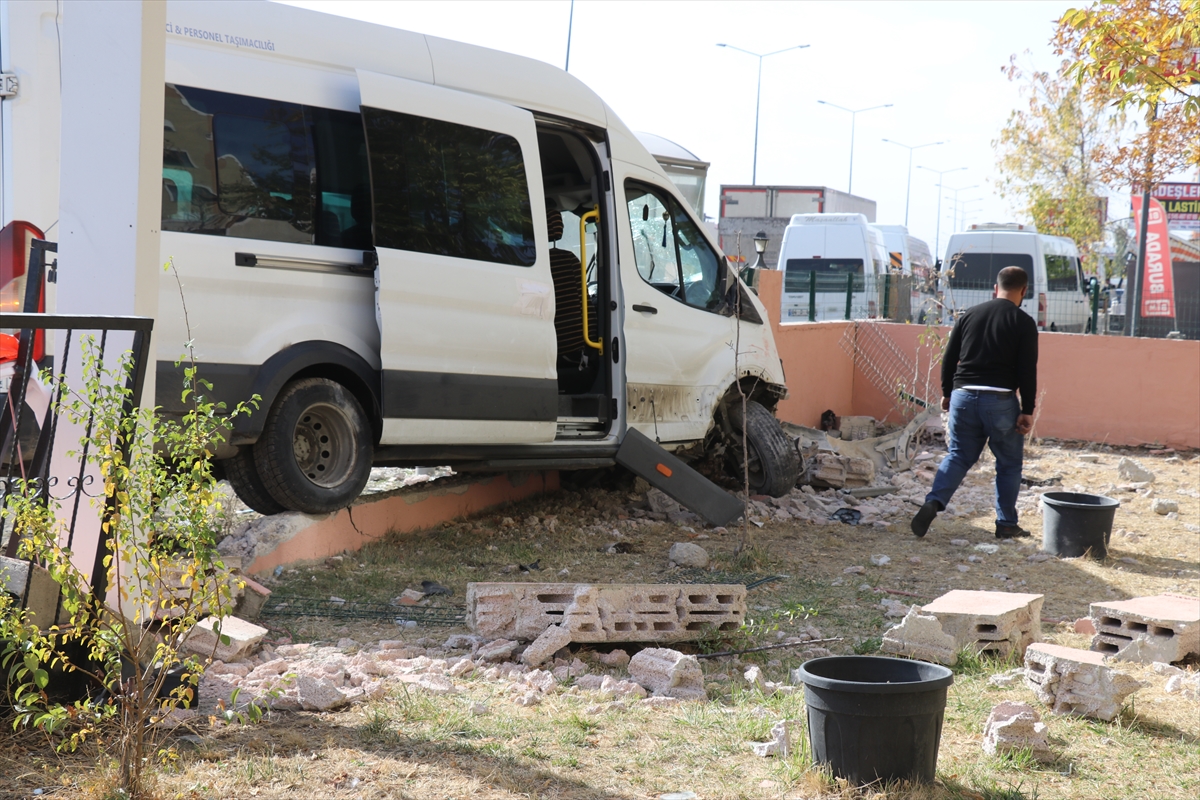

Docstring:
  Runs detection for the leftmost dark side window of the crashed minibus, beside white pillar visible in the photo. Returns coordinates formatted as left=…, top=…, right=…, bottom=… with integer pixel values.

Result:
left=162, top=84, right=313, bottom=243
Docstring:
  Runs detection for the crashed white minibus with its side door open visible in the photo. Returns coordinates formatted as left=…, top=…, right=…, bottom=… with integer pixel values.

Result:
left=0, top=0, right=798, bottom=513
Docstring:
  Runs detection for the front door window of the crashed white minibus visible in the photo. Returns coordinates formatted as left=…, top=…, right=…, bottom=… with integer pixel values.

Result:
left=625, top=184, right=724, bottom=311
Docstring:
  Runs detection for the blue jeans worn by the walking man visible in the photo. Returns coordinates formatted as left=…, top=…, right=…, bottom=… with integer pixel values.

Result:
left=925, top=389, right=1025, bottom=527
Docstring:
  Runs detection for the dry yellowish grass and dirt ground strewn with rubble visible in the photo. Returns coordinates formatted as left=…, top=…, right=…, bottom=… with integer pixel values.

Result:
left=0, top=446, right=1200, bottom=800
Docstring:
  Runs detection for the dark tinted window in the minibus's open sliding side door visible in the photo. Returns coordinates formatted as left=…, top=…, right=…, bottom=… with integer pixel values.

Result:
left=362, top=107, right=536, bottom=266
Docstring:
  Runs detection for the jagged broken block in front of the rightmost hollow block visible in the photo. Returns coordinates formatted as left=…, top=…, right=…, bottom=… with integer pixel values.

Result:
left=1025, top=642, right=1142, bottom=722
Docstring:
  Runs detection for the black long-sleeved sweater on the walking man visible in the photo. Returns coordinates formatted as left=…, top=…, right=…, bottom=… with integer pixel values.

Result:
left=942, top=297, right=1038, bottom=414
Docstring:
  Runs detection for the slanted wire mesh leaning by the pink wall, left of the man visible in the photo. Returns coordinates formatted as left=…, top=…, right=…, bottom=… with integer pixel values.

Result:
left=838, top=321, right=942, bottom=421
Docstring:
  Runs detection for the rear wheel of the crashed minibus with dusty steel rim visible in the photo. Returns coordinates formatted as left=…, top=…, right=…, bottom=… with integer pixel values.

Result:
left=254, top=378, right=373, bottom=513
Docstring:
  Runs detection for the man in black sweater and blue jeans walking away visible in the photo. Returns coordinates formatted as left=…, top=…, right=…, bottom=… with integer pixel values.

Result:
left=912, top=266, right=1038, bottom=539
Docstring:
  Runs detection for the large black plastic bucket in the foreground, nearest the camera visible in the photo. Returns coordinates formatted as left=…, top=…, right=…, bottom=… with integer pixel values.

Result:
left=799, top=656, right=954, bottom=783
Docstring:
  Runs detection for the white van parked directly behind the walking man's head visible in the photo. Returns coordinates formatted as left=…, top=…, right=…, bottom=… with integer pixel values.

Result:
left=941, top=223, right=1091, bottom=333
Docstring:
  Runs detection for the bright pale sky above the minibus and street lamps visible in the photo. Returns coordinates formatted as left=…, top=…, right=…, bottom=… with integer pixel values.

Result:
left=278, top=0, right=1129, bottom=256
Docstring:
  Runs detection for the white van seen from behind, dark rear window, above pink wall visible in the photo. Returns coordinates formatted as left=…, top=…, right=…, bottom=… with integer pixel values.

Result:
left=779, top=213, right=888, bottom=323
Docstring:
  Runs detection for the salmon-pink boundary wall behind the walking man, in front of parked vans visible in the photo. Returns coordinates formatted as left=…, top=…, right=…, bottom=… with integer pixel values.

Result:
left=758, top=271, right=1200, bottom=447
